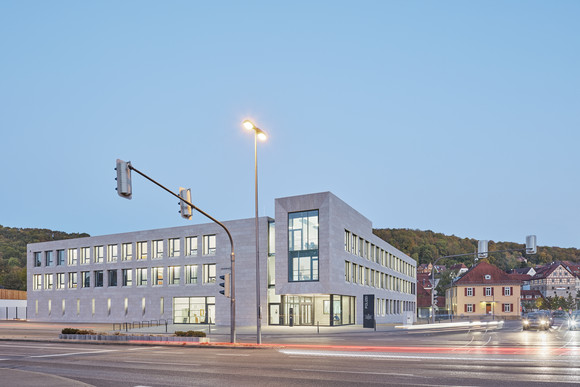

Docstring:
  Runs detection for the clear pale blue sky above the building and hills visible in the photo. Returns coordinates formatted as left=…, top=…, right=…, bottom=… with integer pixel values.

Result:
left=0, top=0, right=580, bottom=248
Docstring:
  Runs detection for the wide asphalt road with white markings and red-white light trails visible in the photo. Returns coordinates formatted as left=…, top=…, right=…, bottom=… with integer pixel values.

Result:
left=0, top=323, right=580, bottom=387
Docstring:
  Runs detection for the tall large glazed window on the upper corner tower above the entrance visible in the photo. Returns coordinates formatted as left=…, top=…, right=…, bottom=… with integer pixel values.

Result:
left=288, top=210, right=318, bottom=282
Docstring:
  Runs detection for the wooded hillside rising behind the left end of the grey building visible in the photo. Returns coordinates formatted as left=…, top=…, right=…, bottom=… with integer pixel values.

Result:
left=0, top=226, right=89, bottom=290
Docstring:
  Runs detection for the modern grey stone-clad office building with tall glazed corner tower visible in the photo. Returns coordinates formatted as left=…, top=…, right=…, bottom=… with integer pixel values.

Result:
left=28, top=192, right=416, bottom=326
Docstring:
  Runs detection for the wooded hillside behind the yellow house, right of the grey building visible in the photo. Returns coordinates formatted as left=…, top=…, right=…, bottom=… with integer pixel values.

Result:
left=374, top=228, right=580, bottom=270
